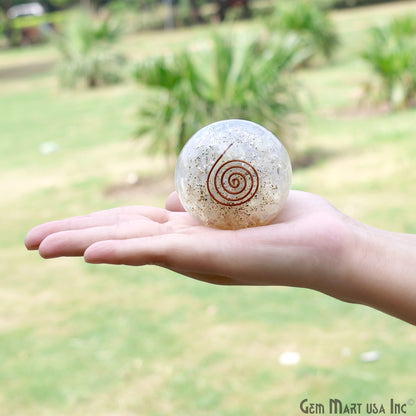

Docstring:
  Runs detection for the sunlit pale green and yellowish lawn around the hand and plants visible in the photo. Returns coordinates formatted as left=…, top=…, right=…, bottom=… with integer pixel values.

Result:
left=0, top=1, right=416, bottom=416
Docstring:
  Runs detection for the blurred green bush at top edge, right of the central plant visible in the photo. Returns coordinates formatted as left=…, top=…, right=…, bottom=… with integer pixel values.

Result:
left=266, top=0, right=339, bottom=59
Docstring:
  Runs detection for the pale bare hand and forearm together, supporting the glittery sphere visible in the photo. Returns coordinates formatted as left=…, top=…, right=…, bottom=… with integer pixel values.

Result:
left=25, top=191, right=416, bottom=324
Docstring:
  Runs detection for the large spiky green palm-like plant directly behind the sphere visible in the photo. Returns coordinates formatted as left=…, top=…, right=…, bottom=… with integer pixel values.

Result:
left=135, top=35, right=308, bottom=155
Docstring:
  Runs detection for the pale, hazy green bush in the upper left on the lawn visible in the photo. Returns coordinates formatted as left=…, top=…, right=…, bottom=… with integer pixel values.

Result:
left=55, top=14, right=125, bottom=88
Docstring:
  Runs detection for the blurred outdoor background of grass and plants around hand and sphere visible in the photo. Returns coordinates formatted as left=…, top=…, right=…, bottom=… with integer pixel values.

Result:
left=0, top=0, right=416, bottom=416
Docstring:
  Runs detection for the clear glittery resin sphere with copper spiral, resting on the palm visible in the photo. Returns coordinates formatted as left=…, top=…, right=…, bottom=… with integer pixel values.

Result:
left=175, top=120, right=292, bottom=229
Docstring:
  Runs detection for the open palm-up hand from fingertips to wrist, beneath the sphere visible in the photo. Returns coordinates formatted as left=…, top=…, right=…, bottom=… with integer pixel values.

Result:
left=25, top=191, right=353, bottom=298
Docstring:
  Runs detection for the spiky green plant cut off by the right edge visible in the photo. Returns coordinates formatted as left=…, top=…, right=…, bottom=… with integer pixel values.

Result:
left=363, top=15, right=416, bottom=109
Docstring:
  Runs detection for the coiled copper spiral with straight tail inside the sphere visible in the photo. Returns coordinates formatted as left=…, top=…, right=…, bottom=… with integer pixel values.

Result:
left=207, top=143, right=259, bottom=206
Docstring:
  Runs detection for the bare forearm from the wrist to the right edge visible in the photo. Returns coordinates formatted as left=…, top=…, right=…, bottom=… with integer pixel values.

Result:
left=344, top=223, right=416, bottom=325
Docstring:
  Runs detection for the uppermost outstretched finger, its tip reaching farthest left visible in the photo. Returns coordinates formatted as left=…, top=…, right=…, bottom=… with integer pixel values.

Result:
left=25, top=206, right=168, bottom=250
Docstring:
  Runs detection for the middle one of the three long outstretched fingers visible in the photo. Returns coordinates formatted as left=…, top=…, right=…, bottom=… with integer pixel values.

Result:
left=39, top=219, right=166, bottom=258
